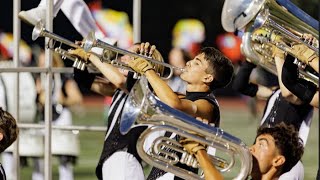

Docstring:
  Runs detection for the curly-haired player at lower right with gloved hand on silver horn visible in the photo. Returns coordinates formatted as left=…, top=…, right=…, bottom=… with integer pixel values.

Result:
left=182, top=123, right=304, bottom=180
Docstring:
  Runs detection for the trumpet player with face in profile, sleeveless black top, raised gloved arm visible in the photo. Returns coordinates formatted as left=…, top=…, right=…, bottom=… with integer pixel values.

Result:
left=129, top=47, right=233, bottom=179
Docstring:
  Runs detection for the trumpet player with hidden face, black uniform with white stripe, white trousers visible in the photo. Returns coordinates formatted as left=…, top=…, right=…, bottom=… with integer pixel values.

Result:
left=70, top=43, right=163, bottom=180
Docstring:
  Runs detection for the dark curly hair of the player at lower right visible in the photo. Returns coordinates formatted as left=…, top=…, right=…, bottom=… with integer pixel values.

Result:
left=257, top=122, right=304, bottom=174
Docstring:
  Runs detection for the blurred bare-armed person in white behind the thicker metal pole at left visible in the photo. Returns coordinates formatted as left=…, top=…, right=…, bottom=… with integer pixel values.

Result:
left=32, top=52, right=82, bottom=180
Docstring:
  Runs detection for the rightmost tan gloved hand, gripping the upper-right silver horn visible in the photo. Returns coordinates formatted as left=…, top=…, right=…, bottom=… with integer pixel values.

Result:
left=291, top=44, right=317, bottom=64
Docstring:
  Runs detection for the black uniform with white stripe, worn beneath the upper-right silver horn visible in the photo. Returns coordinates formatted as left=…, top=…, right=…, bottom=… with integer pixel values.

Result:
left=233, top=61, right=313, bottom=144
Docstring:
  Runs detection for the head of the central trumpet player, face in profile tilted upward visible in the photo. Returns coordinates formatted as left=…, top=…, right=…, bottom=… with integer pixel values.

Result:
left=180, top=47, right=233, bottom=91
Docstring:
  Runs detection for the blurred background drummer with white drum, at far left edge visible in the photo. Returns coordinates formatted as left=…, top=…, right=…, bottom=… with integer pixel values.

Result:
left=0, top=32, right=37, bottom=180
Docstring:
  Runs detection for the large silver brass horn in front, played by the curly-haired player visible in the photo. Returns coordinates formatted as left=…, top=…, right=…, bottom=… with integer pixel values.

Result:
left=120, top=76, right=252, bottom=180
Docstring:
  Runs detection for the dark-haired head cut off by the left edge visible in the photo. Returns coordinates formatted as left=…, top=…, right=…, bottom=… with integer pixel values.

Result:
left=0, top=107, right=19, bottom=153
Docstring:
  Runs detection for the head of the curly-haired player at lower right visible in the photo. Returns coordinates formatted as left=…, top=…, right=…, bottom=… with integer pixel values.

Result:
left=249, top=123, right=303, bottom=179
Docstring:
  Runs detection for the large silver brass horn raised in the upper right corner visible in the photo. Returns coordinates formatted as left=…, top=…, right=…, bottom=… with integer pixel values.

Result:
left=221, top=0, right=319, bottom=86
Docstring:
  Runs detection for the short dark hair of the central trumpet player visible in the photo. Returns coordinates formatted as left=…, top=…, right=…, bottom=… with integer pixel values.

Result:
left=199, top=47, right=234, bottom=90
